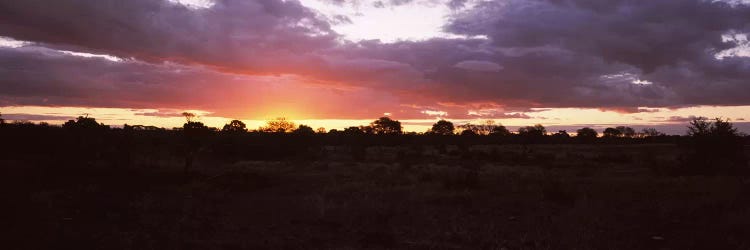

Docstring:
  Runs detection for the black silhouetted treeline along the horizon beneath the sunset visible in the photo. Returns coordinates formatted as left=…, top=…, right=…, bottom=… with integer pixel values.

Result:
left=0, top=113, right=750, bottom=174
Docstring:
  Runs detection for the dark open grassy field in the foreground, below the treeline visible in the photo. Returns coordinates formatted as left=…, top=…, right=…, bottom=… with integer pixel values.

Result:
left=5, top=144, right=750, bottom=249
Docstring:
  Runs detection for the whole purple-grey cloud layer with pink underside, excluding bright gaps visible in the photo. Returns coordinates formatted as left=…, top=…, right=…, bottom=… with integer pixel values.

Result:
left=0, top=0, right=750, bottom=119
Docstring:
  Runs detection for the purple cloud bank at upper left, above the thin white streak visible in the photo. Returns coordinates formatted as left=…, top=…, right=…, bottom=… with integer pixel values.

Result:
left=0, top=0, right=335, bottom=73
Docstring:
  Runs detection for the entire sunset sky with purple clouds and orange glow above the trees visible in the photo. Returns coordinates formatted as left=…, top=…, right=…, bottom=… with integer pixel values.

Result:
left=0, top=0, right=750, bottom=134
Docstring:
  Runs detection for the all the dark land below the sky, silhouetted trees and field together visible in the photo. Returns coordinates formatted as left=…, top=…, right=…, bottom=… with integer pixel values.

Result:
left=0, top=114, right=750, bottom=249
